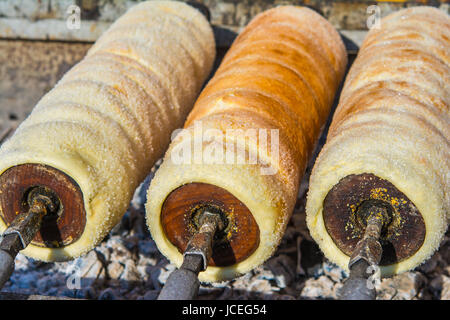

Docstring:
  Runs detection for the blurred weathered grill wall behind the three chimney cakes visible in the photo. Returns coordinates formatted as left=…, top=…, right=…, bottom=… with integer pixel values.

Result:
left=0, top=0, right=450, bottom=132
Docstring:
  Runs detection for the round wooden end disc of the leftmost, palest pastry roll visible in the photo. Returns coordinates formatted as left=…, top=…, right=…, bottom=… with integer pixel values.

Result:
left=0, top=163, right=86, bottom=248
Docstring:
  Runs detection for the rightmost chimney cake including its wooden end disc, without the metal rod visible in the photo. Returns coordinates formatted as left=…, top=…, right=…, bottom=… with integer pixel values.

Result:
left=306, top=7, right=450, bottom=275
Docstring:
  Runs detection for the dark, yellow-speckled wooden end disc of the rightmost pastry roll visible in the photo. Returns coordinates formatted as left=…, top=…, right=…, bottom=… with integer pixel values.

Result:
left=323, top=173, right=426, bottom=265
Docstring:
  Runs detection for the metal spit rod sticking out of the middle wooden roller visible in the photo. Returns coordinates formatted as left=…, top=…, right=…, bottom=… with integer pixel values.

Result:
left=158, top=211, right=224, bottom=300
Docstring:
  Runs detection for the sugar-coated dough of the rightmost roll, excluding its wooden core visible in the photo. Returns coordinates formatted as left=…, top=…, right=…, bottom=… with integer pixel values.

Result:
left=306, top=7, right=450, bottom=276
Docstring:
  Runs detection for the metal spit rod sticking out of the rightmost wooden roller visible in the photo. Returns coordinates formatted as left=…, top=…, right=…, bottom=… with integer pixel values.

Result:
left=339, top=206, right=391, bottom=300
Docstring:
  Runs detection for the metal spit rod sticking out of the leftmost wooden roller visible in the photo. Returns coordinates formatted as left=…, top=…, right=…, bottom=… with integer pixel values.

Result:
left=0, top=187, right=58, bottom=289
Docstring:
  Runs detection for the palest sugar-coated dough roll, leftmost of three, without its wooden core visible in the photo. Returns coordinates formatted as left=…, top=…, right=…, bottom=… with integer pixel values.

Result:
left=0, top=1, right=215, bottom=261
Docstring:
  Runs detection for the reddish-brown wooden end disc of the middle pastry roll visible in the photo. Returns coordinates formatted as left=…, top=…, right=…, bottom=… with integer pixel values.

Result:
left=160, top=183, right=260, bottom=267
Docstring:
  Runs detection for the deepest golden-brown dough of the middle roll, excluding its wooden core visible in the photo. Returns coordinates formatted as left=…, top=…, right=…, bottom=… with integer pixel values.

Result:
left=146, top=6, right=347, bottom=282
